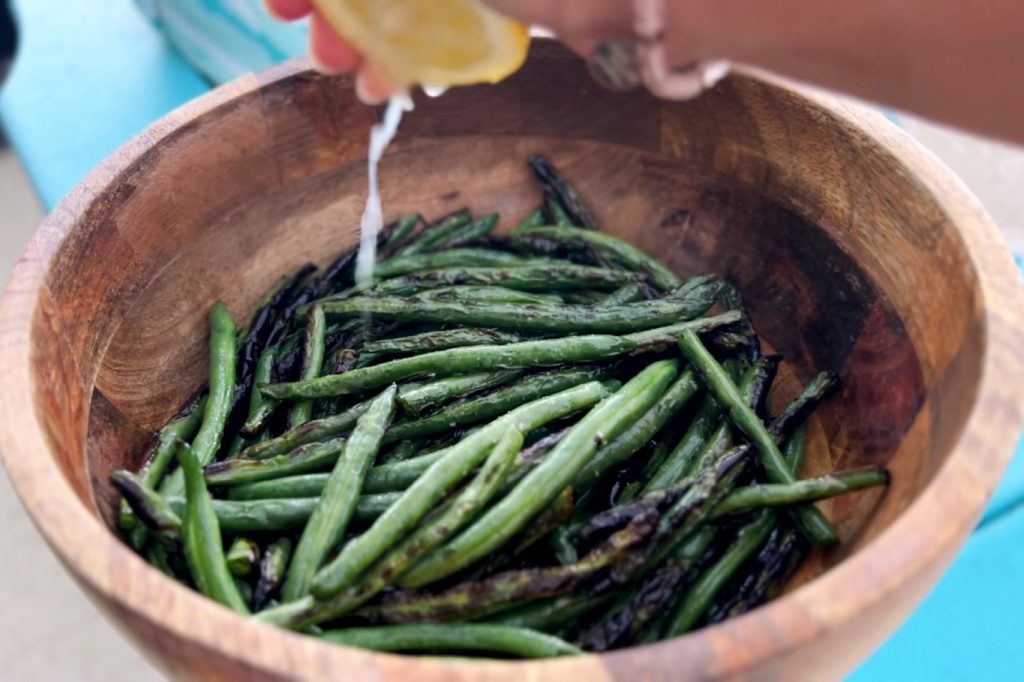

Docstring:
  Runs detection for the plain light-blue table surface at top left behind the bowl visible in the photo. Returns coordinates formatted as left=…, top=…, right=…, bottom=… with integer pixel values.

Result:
left=0, top=0, right=209, bottom=210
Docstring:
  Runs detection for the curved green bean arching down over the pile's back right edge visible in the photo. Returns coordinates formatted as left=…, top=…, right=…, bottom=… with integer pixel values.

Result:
left=509, top=227, right=681, bottom=291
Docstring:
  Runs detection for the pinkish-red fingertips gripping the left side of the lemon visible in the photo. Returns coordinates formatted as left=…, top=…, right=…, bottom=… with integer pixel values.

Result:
left=265, top=0, right=392, bottom=104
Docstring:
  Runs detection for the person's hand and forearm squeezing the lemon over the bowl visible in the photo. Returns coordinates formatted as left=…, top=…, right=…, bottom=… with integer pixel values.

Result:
left=266, top=0, right=1024, bottom=141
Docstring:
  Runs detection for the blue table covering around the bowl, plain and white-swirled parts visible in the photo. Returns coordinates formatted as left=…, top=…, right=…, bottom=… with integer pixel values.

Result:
left=0, top=0, right=1024, bottom=682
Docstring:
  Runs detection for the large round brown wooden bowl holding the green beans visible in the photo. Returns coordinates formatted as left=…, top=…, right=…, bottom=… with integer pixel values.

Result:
left=0, top=43, right=1022, bottom=682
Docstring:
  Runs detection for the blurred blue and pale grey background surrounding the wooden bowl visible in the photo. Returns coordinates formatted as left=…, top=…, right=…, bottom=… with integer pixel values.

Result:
left=0, top=0, right=1024, bottom=682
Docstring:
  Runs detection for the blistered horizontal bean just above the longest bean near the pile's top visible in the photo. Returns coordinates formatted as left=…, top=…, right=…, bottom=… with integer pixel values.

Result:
left=335, top=261, right=637, bottom=296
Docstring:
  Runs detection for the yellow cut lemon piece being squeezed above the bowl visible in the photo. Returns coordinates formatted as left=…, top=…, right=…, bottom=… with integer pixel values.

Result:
left=313, top=0, right=529, bottom=89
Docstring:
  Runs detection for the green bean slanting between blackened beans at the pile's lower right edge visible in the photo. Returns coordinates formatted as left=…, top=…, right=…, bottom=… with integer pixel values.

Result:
left=667, top=510, right=777, bottom=637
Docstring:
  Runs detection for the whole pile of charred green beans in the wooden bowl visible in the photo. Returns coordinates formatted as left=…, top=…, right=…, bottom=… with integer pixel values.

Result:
left=112, top=157, right=889, bottom=657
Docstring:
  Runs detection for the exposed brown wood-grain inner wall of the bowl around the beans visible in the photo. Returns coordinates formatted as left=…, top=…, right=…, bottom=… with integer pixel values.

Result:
left=32, top=43, right=984, bottom=614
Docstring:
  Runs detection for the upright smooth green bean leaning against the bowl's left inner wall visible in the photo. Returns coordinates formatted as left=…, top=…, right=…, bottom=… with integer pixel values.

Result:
left=160, top=301, right=234, bottom=495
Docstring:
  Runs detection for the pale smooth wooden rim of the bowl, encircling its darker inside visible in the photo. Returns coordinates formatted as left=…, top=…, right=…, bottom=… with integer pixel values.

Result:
left=0, top=59, right=1024, bottom=680
